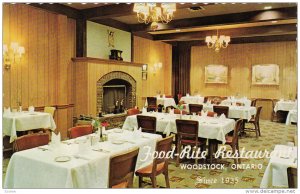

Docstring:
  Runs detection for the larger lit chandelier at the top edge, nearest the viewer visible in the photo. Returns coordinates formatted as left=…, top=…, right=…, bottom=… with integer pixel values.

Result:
left=133, top=3, right=176, bottom=30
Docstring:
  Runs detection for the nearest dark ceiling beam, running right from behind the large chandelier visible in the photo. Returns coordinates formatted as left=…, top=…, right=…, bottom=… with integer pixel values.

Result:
left=130, top=7, right=297, bottom=32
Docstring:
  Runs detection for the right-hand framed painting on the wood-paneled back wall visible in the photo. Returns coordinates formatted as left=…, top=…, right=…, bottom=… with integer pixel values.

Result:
left=252, top=64, right=279, bottom=85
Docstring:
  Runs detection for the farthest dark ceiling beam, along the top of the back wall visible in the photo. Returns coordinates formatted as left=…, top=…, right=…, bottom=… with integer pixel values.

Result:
left=166, top=34, right=297, bottom=47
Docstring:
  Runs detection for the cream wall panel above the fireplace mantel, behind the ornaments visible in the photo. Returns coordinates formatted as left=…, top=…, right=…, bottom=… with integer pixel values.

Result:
left=87, top=21, right=131, bottom=62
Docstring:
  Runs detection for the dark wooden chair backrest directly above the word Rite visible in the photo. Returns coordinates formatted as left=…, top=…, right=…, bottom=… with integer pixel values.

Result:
left=176, top=119, right=199, bottom=141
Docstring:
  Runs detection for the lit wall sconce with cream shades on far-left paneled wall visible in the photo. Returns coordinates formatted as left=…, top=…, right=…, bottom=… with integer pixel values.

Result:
left=3, top=42, right=25, bottom=70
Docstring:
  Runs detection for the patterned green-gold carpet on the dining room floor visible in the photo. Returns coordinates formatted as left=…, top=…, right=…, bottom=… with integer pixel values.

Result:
left=2, top=120, right=297, bottom=189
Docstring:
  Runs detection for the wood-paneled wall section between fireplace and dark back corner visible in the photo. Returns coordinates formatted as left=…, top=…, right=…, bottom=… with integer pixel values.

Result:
left=133, top=36, right=172, bottom=103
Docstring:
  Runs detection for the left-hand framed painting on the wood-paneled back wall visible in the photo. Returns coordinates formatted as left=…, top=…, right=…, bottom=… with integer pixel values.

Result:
left=205, top=65, right=228, bottom=84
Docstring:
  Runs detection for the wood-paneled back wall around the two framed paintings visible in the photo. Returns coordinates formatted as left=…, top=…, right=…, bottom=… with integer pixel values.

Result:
left=191, top=42, right=297, bottom=118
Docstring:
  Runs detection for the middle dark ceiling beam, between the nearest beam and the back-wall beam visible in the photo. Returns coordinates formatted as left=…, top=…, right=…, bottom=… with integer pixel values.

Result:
left=153, top=24, right=297, bottom=41
